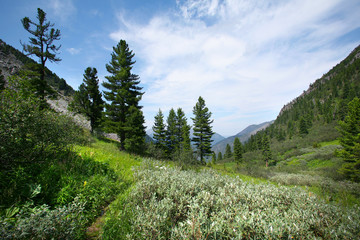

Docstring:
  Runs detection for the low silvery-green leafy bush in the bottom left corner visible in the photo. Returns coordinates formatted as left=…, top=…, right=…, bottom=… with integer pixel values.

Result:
left=0, top=198, right=87, bottom=239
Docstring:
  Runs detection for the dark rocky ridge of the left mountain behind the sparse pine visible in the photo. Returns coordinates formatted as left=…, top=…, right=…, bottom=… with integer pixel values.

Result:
left=0, top=39, right=75, bottom=96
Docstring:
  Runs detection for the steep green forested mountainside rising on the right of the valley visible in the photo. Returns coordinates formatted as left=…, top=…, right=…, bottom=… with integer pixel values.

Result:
left=246, top=46, right=360, bottom=151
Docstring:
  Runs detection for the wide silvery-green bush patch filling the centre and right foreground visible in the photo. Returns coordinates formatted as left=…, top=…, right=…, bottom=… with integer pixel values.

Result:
left=103, top=158, right=360, bottom=239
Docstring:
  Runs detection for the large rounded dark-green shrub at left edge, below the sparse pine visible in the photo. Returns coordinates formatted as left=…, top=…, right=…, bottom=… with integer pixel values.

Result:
left=0, top=78, right=83, bottom=170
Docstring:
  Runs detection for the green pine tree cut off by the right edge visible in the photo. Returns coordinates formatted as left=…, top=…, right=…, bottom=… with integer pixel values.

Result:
left=338, top=97, right=360, bottom=182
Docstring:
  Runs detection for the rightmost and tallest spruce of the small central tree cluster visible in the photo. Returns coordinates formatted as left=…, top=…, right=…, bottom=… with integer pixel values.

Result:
left=192, top=97, right=214, bottom=164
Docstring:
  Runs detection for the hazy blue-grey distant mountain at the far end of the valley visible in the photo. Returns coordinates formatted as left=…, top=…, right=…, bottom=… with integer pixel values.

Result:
left=212, top=121, right=274, bottom=154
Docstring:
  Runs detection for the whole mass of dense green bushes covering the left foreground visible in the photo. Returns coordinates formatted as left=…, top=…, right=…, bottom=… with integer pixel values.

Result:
left=0, top=79, right=120, bottom=239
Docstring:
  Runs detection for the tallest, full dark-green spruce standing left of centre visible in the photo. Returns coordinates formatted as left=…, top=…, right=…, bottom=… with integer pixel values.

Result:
left=103, top=40, right=146, bottom=150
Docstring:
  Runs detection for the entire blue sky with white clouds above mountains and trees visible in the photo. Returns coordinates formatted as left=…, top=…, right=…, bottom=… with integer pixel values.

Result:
left=0, top=0, right=360, bottom=137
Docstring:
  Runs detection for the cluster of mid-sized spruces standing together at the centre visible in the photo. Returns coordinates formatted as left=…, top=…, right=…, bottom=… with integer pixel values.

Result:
left=152, top=96, right=214, bottom=164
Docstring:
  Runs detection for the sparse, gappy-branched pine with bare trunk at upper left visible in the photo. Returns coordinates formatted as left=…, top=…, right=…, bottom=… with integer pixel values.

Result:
left=21, top=8, right=61, bottom=107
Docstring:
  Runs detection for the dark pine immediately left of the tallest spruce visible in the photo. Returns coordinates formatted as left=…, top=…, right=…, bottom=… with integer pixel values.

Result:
left=70, top=67, right=104, bottom=133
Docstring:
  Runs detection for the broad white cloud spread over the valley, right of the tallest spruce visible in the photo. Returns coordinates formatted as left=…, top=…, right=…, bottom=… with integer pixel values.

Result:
left=110, top=0, right=360, bottom=135
